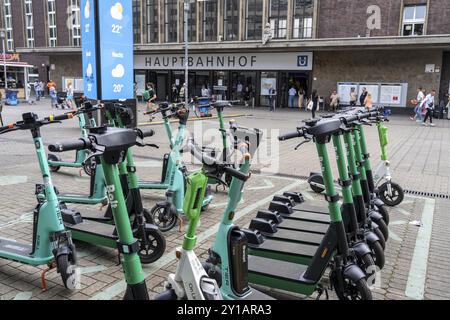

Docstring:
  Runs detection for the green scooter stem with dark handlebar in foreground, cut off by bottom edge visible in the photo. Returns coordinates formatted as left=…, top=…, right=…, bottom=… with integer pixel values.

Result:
left=48, top=127, right=153, bottom=300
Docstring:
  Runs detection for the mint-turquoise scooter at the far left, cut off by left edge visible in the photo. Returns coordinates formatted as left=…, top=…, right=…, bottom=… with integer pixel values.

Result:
left=0, top=113, right=79, bottom=289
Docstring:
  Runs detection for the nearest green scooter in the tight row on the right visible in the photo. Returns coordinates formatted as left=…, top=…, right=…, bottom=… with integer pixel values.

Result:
left=249, top=119, right=372, bottom=300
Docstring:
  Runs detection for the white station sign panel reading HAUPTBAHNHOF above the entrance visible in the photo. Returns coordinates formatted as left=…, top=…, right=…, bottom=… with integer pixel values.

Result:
left=135, top=52, right=313, bottom=71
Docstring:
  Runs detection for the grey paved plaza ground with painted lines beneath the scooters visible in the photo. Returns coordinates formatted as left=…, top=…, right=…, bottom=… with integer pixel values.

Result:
left=0, top=100, right=450, bottom=300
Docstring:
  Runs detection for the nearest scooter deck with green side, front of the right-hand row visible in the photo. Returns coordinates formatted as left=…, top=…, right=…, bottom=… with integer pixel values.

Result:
left=248, top=256, right=317, bottom=295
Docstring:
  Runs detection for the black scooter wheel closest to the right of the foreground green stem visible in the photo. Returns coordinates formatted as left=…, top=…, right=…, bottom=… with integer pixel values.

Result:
left=138, top=229, right=166, bottom=264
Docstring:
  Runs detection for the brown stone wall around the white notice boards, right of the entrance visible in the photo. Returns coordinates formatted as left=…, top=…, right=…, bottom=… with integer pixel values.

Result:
left=312, top=50, right=442, bottom=105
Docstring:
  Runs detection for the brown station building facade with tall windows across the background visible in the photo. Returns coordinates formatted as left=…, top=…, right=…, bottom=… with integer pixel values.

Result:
left=0, top=0, right=450, bottom=108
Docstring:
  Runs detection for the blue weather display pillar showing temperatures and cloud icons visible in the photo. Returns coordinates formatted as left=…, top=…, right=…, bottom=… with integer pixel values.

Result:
left=81, top=0, right=134, bottom=100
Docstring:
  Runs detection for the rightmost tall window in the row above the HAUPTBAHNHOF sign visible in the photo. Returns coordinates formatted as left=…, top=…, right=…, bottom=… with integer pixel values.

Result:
left=292, top=0, right=314, bottom=39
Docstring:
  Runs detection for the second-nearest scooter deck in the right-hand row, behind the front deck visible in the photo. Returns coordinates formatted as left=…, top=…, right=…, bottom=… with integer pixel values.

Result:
left=248, top=239, right=318, bottom=265
